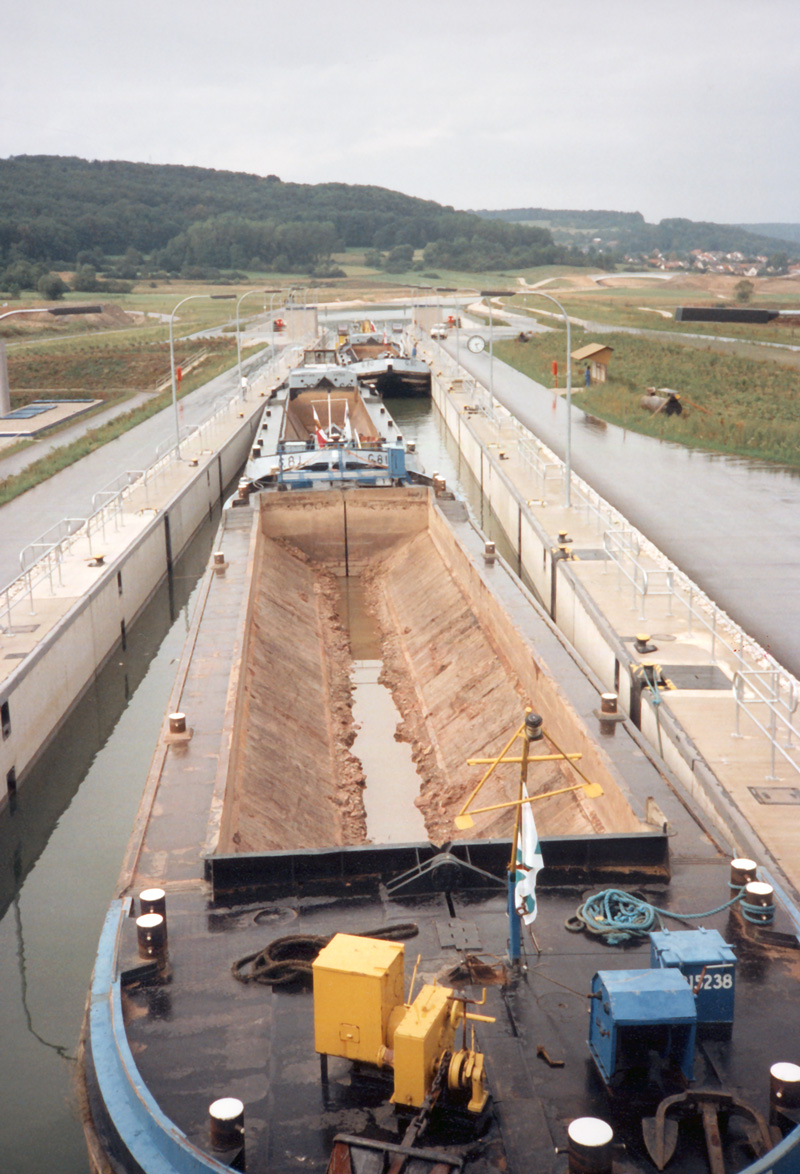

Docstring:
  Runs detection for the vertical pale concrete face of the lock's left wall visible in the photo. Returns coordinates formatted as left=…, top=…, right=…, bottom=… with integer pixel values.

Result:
left=0, top=413, right=260, bottom=784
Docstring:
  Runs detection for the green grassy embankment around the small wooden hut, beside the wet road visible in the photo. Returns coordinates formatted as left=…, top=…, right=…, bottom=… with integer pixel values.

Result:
left=495, top=329, right=800, bottom=467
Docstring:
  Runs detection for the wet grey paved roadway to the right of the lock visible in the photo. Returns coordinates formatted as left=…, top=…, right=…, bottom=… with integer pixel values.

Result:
left=444, top=328, right=800, bottom=677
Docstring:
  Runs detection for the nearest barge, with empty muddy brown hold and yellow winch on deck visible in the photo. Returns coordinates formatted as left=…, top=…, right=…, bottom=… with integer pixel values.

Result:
left=83, top=387, right=800, bottom=1174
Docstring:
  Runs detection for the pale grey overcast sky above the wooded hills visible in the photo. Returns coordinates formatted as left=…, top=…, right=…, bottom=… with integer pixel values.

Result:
left=0, top=0, right=800, bottom=222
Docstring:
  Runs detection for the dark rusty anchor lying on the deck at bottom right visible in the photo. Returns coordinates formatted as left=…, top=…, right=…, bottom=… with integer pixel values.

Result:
left=641, top=1088, right=773, bottom=1174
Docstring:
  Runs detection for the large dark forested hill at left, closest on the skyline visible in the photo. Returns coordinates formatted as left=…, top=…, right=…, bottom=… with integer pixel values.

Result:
left=0, top=155, right=572, bottom=271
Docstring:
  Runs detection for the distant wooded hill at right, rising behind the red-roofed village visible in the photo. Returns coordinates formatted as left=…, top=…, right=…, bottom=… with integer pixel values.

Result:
left=478, top=208, right=800, bottom=256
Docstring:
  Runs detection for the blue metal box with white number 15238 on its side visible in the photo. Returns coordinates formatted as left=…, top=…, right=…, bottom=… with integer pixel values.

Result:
left=650, top=929, right=737, bottom=1026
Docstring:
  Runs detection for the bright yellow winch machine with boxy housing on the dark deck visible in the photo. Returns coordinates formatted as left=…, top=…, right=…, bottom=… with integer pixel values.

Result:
left=312, top=933, right=495, bottom=1114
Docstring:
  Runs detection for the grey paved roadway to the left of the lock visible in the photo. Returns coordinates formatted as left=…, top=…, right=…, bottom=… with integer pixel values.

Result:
left=0, top=349, right=269, bottom=588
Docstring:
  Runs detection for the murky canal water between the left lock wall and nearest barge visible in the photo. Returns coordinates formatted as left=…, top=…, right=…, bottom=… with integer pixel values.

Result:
left=0, top=512, right=220, bottom=1174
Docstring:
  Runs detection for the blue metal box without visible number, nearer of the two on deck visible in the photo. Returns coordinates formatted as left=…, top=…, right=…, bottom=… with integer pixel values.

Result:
left=589, top=967, right=697, bottom=1085
